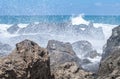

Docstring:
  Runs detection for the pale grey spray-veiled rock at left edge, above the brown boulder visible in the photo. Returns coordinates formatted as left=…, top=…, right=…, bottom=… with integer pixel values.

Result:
left=0, top=42, right=12, bottom=57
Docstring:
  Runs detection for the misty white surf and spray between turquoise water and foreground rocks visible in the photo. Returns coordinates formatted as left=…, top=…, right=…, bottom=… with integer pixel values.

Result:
left=0, top=14, right=117, bottom=64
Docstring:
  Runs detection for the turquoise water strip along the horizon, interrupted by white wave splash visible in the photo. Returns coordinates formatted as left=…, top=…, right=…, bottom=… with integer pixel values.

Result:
left=0, top=15, right=120, bottom=25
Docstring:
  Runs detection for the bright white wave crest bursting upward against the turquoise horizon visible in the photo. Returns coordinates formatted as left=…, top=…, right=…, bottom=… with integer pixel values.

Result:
left=71, top=14, right=89, bottom=25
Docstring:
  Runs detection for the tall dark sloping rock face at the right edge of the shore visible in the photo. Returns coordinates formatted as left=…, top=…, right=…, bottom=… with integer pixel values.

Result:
left=98, top=26, right=120, bottom=79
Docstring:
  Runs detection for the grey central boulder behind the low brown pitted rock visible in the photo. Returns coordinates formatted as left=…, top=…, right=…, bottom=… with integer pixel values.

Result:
left=47, top=40, right=80, bottom=68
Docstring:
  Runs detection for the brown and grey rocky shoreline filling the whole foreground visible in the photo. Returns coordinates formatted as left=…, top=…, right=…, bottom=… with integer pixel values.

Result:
left=0, top=26, right=120, bottom=79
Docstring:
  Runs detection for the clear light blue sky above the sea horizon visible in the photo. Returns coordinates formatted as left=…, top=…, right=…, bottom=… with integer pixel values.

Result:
left=0, top=0, right=120, bottom=15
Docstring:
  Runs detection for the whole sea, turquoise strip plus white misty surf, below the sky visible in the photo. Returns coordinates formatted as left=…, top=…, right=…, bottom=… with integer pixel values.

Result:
left=0, top=14, right=120, bottom=62
